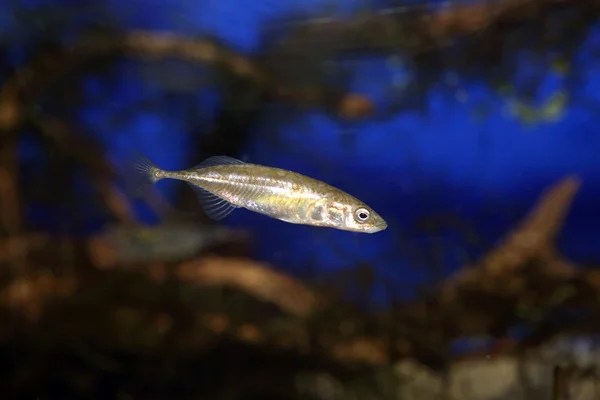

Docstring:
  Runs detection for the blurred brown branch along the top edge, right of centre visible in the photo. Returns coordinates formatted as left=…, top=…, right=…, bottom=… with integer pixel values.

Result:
left=268, top=0, right=576, bottom=56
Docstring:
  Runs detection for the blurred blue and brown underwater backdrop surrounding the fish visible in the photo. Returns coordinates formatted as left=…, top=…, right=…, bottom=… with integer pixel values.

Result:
left=0, top=0, right=600, bottom=399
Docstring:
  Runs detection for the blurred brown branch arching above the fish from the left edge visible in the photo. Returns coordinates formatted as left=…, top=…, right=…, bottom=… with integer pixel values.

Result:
left=0, top=30, right=321, bottom=130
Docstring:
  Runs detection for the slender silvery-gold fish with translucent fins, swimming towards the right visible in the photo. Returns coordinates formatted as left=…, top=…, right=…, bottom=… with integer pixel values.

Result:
left=133, top=153, right=387, bottom=233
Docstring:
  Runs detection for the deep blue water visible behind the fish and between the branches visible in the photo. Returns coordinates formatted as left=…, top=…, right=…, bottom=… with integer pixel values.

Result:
left=0, top=0, right=600, bottom=356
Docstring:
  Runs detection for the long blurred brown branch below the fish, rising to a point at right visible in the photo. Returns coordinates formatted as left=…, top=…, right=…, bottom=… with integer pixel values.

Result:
left=2, top=177, right=600, bottom=367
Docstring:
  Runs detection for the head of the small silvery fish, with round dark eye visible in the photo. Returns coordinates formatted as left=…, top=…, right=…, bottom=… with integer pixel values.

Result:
left=320, top=199, right=387, bottom=233
